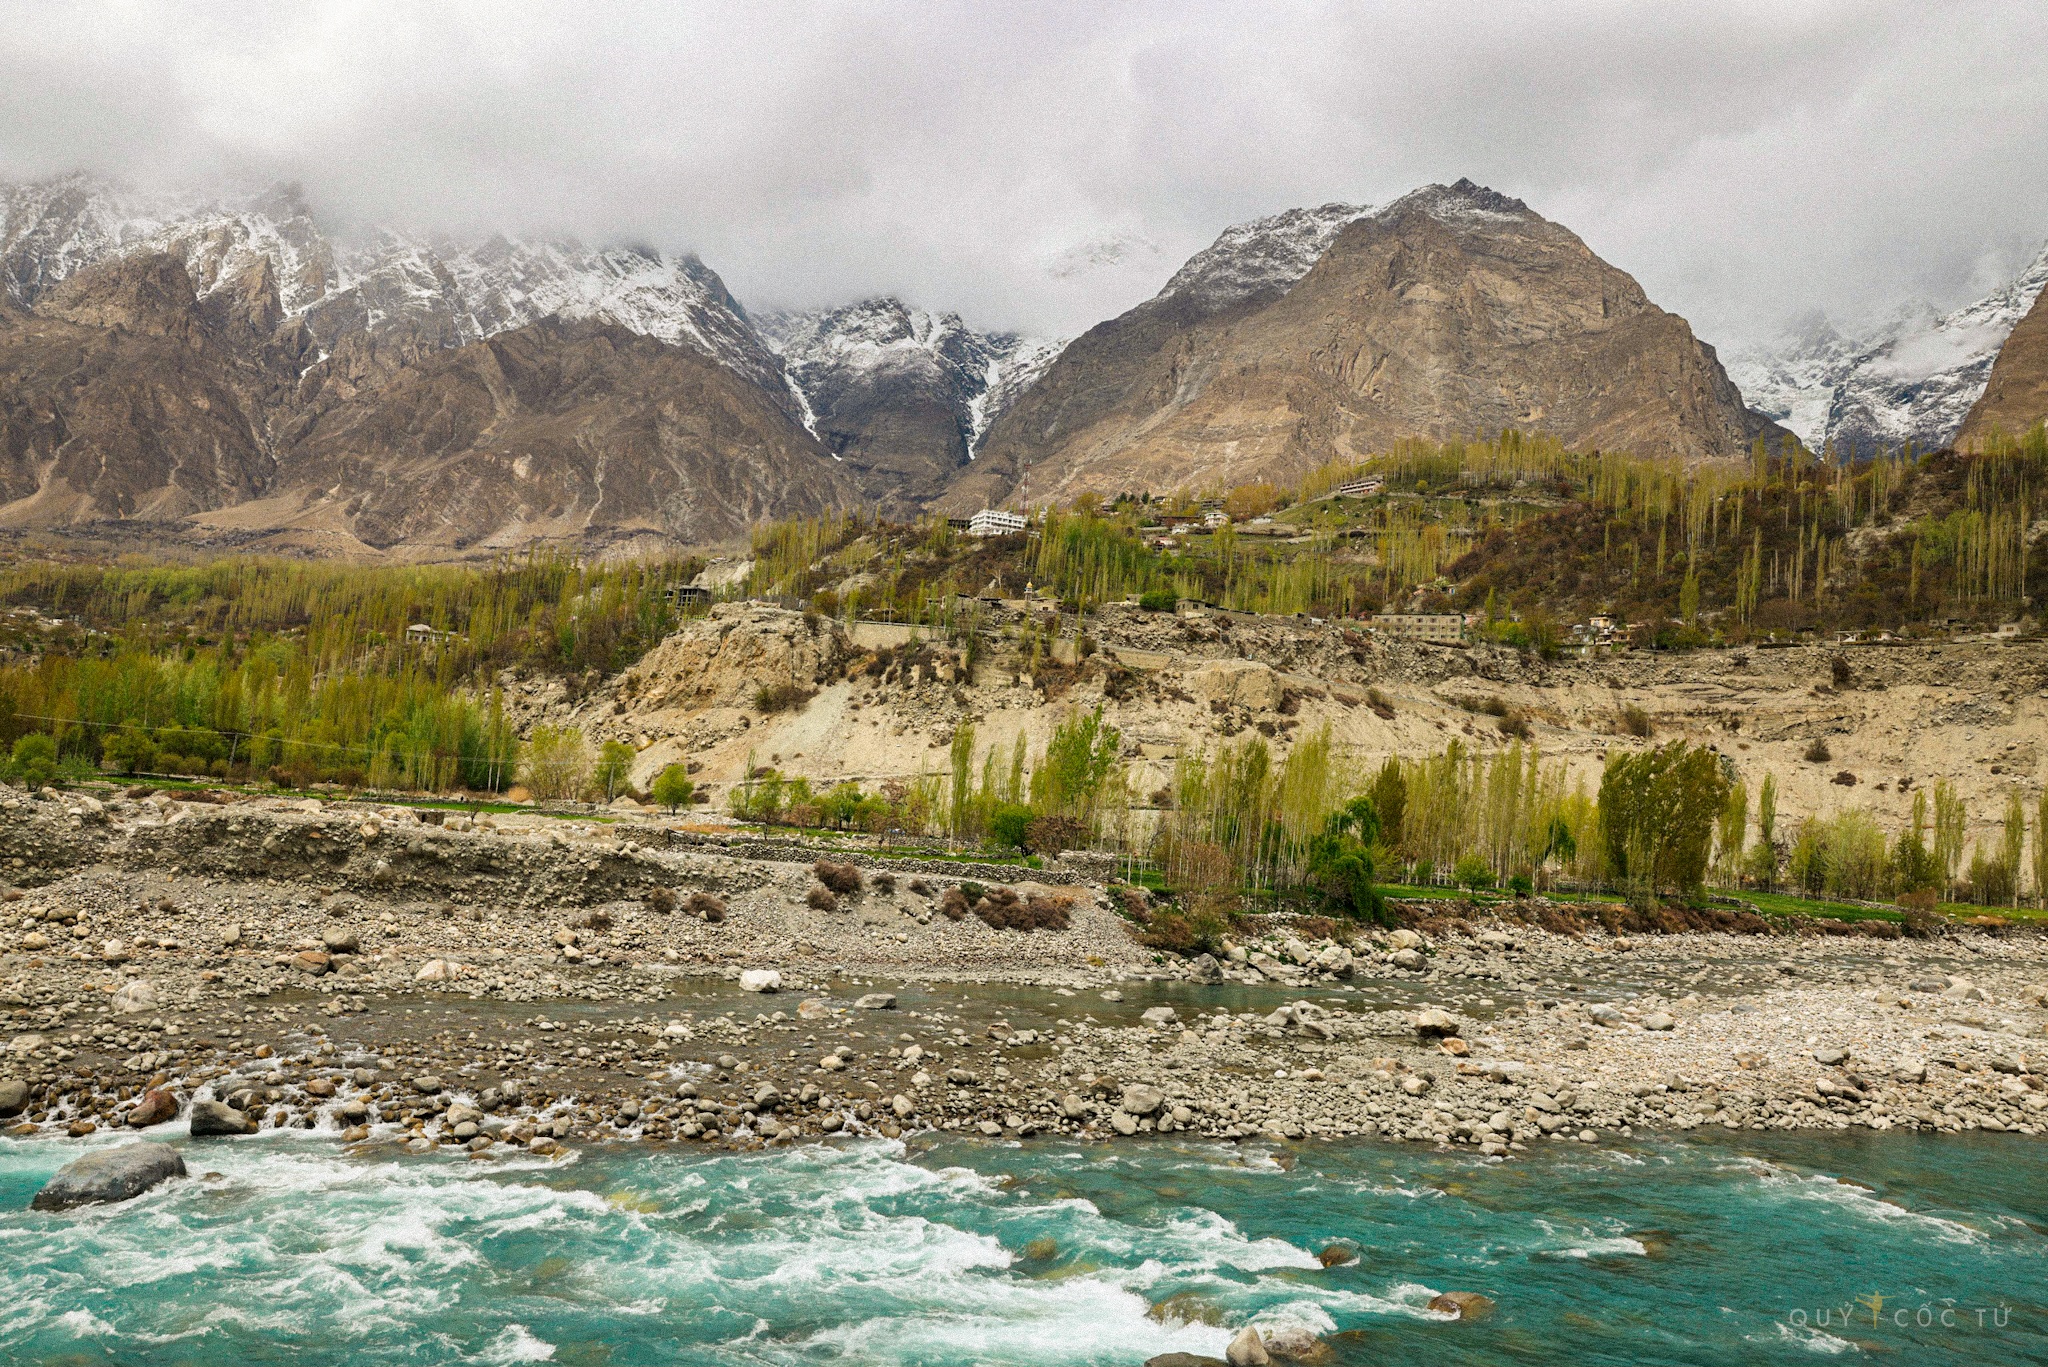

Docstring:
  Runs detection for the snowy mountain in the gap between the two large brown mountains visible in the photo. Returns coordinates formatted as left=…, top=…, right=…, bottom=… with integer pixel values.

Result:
left=756, top=297, right=1063, bottom=459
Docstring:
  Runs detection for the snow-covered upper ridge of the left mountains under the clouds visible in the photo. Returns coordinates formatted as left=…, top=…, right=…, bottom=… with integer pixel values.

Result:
left=0, top=174, right=797, bottom=401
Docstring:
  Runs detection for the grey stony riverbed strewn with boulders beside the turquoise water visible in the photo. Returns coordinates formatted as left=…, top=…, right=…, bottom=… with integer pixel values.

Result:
left=0, top=793, right=2048, bottom=1160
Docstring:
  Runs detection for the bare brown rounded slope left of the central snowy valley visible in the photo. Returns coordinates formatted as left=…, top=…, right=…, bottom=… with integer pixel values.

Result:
left=235, top=320, right=858, bottom=553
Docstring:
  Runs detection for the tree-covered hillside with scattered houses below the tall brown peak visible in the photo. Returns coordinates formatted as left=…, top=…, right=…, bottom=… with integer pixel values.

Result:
left=729, top=426, right=2048, bottom=650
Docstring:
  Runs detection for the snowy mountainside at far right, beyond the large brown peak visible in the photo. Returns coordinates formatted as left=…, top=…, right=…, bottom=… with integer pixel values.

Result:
left=1729, top=248, right=2048, bottom=451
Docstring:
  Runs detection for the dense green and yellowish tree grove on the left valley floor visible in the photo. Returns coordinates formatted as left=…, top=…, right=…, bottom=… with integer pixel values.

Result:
left=0, top=555, right=696, bottom=791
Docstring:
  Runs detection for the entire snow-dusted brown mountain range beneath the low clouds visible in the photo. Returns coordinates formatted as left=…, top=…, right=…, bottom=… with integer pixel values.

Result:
left=0, top=174, right=2048, bottom=555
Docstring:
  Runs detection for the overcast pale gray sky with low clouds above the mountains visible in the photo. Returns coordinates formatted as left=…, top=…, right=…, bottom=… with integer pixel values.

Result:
left=0, top=0, right=2048, bottom=344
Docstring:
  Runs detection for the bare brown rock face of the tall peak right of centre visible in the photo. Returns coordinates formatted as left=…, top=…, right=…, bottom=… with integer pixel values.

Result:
left=952, top=180, right=1769, bottom=504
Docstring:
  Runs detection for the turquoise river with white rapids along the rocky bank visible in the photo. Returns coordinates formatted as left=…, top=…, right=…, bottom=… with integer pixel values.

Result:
left=0, top=1133, right=2048, bottom=1367
